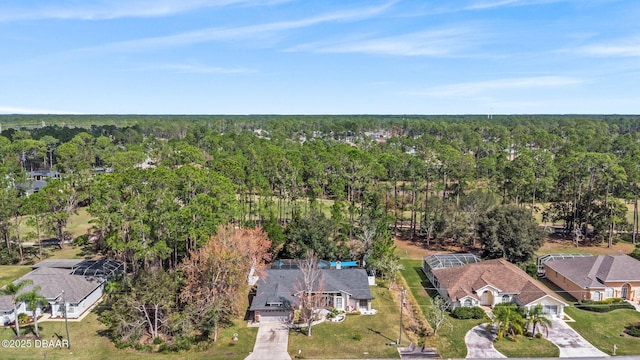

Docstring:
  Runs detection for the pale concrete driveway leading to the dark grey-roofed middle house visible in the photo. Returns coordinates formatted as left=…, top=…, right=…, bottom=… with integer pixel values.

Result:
left=245, top=322, right=291, bottom=360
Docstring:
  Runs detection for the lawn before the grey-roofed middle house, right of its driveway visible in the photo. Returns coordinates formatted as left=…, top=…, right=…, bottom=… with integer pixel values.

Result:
left=289, top=287, right=400, bottom=359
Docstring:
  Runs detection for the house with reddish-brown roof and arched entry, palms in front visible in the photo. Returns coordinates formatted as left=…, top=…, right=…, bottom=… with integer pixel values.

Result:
left=432, top=259, right=568, bottom=316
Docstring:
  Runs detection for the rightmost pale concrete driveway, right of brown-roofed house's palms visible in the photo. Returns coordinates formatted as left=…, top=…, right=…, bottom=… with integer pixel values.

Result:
left=547, top=319, right=609, bottom=357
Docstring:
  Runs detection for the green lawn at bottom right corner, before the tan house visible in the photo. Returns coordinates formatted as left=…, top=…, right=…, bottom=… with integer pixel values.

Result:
left=564, top=306, right=640, bottom=355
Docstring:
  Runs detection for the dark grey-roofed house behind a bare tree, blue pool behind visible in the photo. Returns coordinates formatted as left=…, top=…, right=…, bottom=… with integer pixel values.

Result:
left=249, top=268, right=373, bottom=321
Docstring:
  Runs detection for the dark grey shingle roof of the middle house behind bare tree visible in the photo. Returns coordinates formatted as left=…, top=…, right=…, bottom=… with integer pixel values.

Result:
left=250, top=269, right=373, bottom=311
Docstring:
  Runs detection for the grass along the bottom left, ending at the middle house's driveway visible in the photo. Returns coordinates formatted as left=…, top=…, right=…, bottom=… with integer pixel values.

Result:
left=0, top=313, right=257, bottom=360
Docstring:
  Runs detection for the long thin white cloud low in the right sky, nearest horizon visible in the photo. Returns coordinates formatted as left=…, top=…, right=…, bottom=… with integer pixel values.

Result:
left=405, top=76, right=584, bottom=97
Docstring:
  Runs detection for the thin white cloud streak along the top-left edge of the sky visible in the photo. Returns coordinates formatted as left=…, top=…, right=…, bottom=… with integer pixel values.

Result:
left=0, top=0, right=290, bottom=22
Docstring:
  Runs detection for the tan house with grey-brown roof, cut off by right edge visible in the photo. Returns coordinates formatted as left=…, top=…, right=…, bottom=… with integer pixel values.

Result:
left=544, top=255, right=640, bottom=300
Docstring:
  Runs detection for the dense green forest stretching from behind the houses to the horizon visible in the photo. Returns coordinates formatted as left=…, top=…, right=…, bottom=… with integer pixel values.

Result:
left=0, top=115, right=640, bottom=348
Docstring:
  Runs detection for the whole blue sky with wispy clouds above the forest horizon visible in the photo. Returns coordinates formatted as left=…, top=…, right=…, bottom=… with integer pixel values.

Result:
left=0, top=0, right=640, bottom=114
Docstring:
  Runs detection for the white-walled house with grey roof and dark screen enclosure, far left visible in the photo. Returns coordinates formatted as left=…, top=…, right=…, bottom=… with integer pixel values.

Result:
left=0, top=259, right=123, bottom=325
